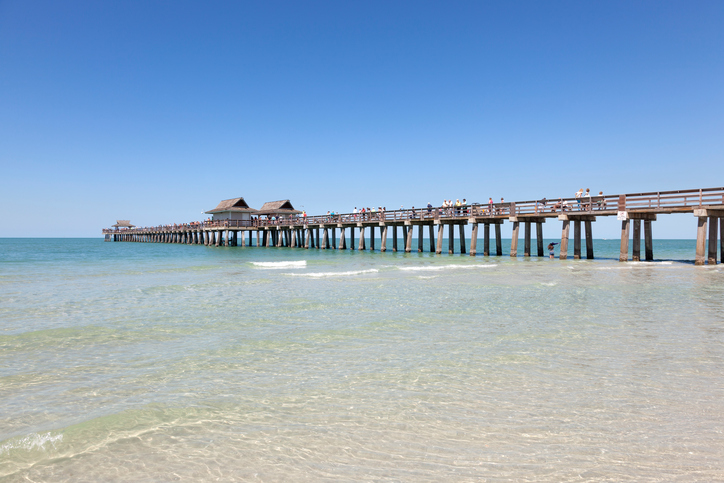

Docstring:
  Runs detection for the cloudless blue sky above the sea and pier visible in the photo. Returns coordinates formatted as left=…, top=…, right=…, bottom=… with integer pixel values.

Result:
left=0, top=0, right=724, bottom=238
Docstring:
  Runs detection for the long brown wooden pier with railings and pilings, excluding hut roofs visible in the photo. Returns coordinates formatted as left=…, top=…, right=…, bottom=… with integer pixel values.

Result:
left=103, top=188, right=724, bottom=265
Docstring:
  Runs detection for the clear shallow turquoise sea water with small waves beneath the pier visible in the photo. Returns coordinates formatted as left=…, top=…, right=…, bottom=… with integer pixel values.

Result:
left=0, top=239, right=724, bottom=482
